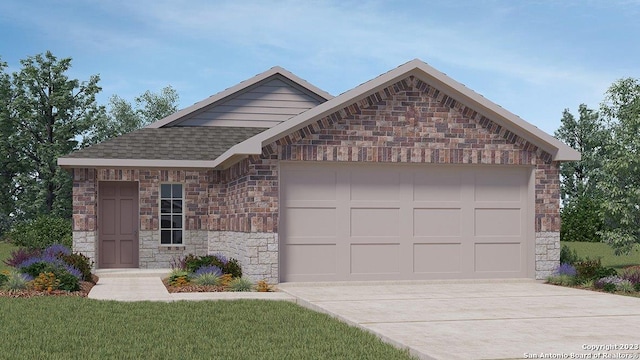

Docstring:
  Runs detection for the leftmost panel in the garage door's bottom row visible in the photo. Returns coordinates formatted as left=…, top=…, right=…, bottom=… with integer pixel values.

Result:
left=284, top=244, right=337, bottom=280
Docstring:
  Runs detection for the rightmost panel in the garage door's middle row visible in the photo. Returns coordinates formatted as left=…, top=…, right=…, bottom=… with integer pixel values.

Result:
left=475, top=209, right=522, bottom=236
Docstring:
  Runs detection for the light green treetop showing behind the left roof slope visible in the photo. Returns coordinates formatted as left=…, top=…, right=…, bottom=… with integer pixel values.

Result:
left=84, top=86, right=179, bottom=145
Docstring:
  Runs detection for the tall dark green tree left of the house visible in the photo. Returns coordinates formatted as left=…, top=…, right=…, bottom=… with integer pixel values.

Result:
left=1, top=52, right=101, bottom=219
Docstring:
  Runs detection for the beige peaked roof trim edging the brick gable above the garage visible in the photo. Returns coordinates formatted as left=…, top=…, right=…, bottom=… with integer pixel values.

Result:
left=220, top=59, right=580, bottom=164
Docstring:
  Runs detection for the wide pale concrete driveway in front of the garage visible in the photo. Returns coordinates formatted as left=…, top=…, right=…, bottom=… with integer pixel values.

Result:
left=278, top=280, right=640, bottom=360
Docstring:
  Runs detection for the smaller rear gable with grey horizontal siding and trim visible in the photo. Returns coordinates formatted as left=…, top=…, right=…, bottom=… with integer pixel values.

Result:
left=148, top=67, right=333, bottom=128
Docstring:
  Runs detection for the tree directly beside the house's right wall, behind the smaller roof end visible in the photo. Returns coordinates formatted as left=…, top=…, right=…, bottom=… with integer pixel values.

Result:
left=555, top=104, right=608, bottom=242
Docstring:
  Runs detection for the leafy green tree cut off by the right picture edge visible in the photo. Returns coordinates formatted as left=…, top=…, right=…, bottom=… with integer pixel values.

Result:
left=601, top=78, right=640, bottom=253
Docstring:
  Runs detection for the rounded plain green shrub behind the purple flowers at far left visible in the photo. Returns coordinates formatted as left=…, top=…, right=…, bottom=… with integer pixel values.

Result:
left=7, top=215, right=72, bottom=250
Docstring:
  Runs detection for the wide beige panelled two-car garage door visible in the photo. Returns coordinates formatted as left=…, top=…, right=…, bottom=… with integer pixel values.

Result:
left=280, top=162, right=535, bottom=281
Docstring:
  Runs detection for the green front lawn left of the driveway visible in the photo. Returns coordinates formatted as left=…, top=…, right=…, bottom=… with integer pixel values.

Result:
left=0, top=297, right=410, bottom=359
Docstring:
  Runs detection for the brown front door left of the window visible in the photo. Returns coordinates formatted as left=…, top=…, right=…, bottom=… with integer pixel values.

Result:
left=98, top=181, right=140, bottom=268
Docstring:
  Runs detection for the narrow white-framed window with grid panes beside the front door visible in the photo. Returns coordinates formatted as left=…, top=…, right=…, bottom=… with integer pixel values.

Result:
left=160, top=184, right=184, bottom=245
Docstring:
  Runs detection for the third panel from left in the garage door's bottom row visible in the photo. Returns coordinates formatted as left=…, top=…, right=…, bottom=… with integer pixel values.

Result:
left=413, top=243, right=462, bottom=274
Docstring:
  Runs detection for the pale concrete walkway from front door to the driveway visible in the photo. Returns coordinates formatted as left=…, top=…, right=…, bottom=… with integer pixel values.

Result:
left=89, top=269, right=296, bottom=302
